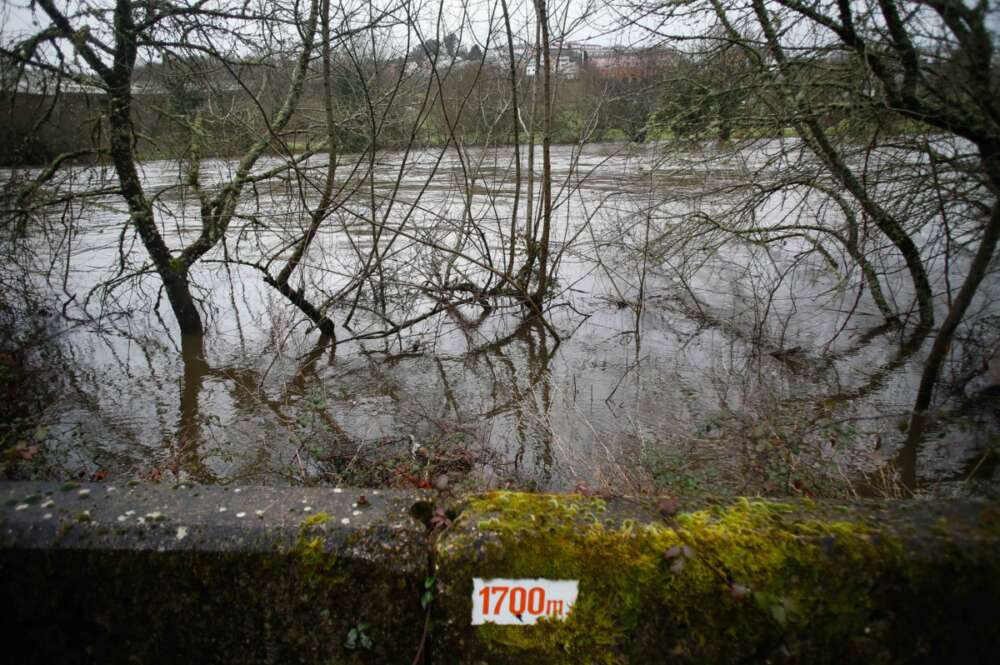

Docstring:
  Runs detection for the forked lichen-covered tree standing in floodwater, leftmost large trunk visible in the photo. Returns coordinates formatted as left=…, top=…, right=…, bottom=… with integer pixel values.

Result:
left=4, top=0, right=332, bottom=335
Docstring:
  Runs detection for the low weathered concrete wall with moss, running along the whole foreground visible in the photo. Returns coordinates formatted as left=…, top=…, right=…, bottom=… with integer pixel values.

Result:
left=0, top=483, right=1000, bottom=663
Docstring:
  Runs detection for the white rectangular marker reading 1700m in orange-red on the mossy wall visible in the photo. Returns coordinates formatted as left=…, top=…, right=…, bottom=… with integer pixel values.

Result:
left=472, top=577, right=578, bottom=626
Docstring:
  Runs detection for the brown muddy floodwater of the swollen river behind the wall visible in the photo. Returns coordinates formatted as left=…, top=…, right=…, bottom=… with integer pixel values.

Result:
left=6, top=145, right=1000, bottom=495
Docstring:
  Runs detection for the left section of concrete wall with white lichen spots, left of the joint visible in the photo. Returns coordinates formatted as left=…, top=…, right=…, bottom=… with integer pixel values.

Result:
left=0, top=483, right=428, bottom=664
